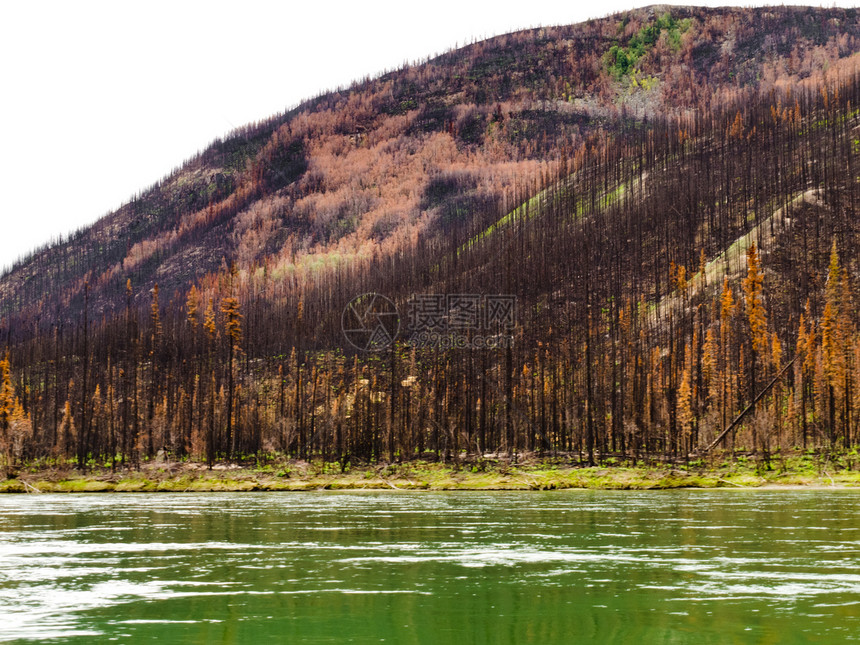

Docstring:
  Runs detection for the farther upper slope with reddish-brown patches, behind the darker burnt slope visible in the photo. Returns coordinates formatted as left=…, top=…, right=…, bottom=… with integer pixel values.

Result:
left=0, top=6, right=860, bottom=323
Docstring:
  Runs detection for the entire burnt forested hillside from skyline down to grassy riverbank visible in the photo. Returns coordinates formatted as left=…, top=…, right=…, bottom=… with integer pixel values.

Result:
left=0, top=8, right=860, bottom=467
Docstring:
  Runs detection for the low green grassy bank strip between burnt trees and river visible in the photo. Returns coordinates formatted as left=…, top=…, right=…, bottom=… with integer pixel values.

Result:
left=0, top=451, right=860, bottom=494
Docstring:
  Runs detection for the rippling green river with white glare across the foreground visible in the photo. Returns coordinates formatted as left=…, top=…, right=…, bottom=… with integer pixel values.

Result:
left=0, top=490, right=860, bottom=645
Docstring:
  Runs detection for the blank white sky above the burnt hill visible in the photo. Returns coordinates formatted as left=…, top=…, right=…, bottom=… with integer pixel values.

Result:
left=0, top=0, right=855, bottom=268
